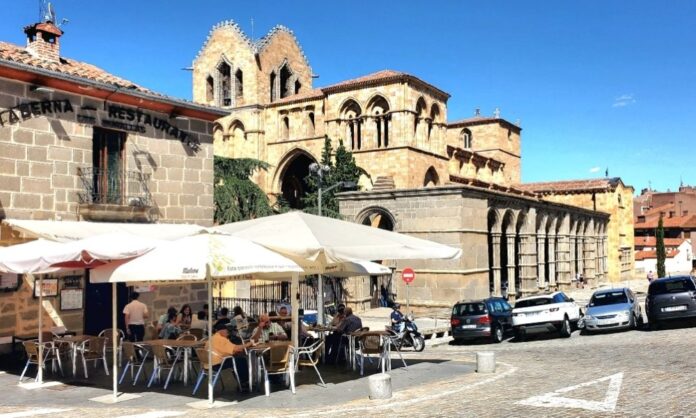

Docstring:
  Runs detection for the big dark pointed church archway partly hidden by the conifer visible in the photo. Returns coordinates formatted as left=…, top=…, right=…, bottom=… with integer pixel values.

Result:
left=276, top=148, right=317, bottom=209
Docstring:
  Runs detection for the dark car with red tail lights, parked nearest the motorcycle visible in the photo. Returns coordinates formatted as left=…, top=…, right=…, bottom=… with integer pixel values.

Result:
left=450, top=297, right=512, bottom=343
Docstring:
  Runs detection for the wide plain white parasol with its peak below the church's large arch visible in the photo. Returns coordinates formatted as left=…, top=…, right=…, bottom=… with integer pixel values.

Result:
left=213, top=211, right=462, bottom=334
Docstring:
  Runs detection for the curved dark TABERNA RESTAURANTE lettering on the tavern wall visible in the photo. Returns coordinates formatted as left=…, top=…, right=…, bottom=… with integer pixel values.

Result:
left=0, top=99, right=200, bottom=151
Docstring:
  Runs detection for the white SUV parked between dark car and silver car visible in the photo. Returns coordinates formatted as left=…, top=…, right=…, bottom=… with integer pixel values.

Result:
left=512, top=292, right=582, bottom=341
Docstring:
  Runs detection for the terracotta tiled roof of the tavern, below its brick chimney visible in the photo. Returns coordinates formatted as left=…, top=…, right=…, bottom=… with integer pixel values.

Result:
left=0, top=41, right=156, bottom=94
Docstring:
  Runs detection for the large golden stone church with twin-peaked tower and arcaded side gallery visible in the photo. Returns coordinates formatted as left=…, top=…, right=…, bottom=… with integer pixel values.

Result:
left=193, top=21, right=633, bottom=307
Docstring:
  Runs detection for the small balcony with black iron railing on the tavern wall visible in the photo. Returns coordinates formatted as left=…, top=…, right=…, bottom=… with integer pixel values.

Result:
left=77, top=167, right=157, bottom=223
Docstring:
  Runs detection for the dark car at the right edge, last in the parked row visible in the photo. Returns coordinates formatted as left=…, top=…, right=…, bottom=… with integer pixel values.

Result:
left=645, top=276, right=696, bottom=329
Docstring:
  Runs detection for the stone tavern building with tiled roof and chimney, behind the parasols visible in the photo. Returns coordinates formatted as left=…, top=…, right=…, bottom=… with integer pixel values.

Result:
left=0, top=17, right=227, bottom=346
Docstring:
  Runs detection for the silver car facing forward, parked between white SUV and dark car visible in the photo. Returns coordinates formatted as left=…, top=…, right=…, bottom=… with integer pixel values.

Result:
left=582, top=287, right=643, bottom=332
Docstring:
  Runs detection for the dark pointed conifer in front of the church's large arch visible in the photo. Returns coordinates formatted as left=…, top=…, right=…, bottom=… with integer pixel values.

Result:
left=302, top=137, right=367, bottom=218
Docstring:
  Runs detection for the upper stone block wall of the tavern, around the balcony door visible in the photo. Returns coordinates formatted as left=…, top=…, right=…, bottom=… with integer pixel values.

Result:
left=0, top=75, right=213, bottom=225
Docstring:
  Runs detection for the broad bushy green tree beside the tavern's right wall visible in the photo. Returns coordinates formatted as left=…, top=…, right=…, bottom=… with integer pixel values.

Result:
left=213, top=156, right=283, bottom=224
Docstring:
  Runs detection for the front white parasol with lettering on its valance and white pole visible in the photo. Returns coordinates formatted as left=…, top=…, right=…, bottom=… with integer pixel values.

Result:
left=90, top=234, right=302, bottom=403
